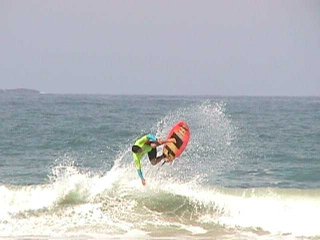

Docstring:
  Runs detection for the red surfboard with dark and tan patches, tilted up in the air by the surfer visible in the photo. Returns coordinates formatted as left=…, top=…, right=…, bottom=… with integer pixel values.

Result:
left=163, top=121, right=190, bottom=162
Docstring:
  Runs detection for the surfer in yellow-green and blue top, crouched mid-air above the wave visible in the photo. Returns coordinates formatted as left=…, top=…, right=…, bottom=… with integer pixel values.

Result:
left=132, top=134, right=176, bottom=185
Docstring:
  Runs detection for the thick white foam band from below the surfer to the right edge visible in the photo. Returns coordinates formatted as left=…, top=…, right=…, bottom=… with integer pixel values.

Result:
left=161, top=183, right=320, bottom=236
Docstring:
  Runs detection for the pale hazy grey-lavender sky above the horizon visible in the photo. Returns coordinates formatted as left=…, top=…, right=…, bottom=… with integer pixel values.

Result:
left=0, top=0, right=320, bottom=96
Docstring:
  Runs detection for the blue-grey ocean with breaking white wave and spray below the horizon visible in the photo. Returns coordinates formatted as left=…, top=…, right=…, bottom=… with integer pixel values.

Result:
left=0, top=93, right=320, bottom=240
